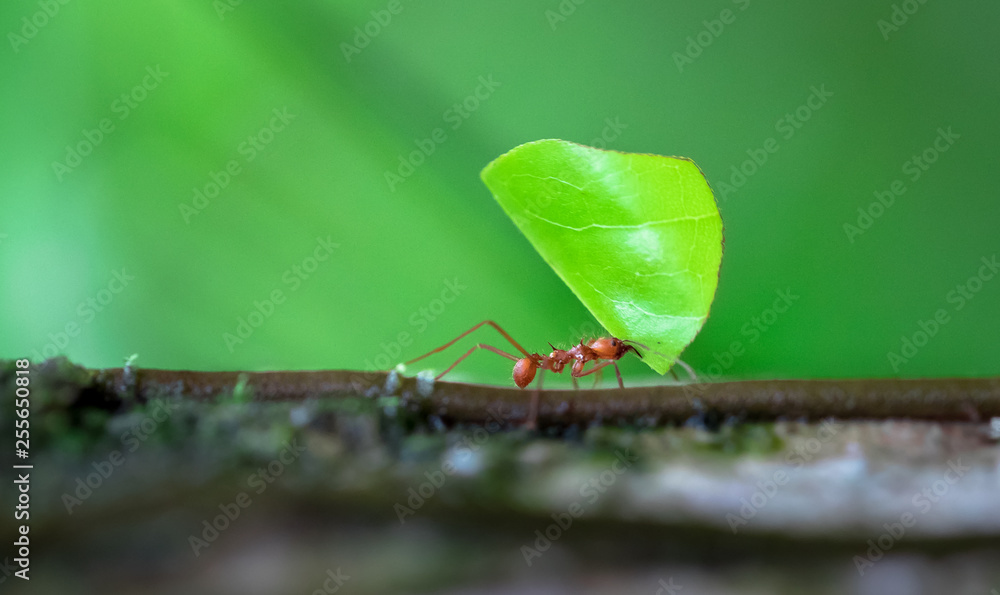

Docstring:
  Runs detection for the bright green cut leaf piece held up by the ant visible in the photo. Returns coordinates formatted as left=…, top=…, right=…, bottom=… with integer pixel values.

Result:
left=481, top=140, right=722, bottom=374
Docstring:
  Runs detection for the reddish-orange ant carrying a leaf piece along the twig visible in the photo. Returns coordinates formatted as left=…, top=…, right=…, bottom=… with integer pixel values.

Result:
left=406, top=320, right=649, bottom=429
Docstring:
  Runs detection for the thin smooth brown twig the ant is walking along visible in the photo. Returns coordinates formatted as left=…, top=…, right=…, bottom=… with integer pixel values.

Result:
left=78, top=368, right=1000, bottom=426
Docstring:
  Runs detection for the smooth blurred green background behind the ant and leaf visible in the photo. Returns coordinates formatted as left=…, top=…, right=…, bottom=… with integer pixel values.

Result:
left=0, top=0, right=1000, bottom=384
